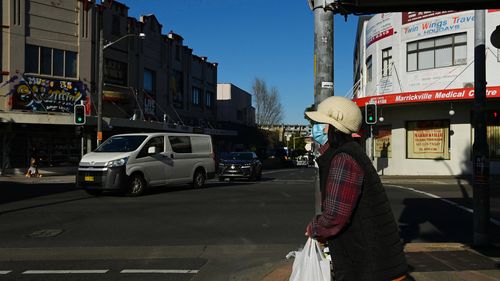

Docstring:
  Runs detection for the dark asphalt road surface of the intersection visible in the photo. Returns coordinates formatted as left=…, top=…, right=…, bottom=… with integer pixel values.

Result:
left=0, top=168, right=498, bottom=281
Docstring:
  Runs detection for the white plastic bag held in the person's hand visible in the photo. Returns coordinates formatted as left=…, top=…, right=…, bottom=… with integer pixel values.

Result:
left=289, top=238, right=331, bottom=281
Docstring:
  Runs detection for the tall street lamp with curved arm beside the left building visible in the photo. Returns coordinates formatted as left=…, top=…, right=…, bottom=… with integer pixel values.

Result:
left=97, top=32, right=146, bottom=146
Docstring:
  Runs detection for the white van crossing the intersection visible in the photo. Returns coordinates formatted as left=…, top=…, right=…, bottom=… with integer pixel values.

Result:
left=77, top=133, right=215, bottom=196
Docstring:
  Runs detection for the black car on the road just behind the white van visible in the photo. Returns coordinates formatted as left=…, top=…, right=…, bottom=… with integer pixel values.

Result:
left=218, top=152, right=262, bottom=181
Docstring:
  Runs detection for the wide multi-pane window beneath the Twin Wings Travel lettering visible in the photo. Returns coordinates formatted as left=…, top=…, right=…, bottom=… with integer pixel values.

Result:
left=406, top=33, right=467, bottom=72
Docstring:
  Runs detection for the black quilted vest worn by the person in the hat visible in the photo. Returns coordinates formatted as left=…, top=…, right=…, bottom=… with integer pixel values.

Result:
left=316, top=142, right=408, bottom=281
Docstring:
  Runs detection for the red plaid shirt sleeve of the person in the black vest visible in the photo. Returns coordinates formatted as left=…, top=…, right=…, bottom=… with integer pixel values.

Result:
left=307, top=144, right=364, bottom=242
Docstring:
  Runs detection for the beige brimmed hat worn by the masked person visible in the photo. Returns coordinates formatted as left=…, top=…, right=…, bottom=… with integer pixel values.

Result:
left=306, top=96, right=363, bottom=134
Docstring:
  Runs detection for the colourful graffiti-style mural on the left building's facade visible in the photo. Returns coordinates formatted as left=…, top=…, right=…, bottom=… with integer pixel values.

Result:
left=11, top=75, right=87, bottom=112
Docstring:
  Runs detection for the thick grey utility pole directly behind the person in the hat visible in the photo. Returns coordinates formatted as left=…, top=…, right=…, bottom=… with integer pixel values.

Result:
left=308, top=0, right=334, bottom=214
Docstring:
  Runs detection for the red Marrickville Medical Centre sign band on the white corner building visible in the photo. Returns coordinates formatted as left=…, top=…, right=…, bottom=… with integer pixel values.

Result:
left=353, top=86, right=500, bottom=106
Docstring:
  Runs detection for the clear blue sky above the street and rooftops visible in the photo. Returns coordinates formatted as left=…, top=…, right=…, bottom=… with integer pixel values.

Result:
left=120, top=0, right=357, bottom=124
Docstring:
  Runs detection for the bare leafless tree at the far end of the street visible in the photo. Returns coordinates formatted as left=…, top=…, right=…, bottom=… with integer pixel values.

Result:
left=252, top=78, right=283, bottom=125
